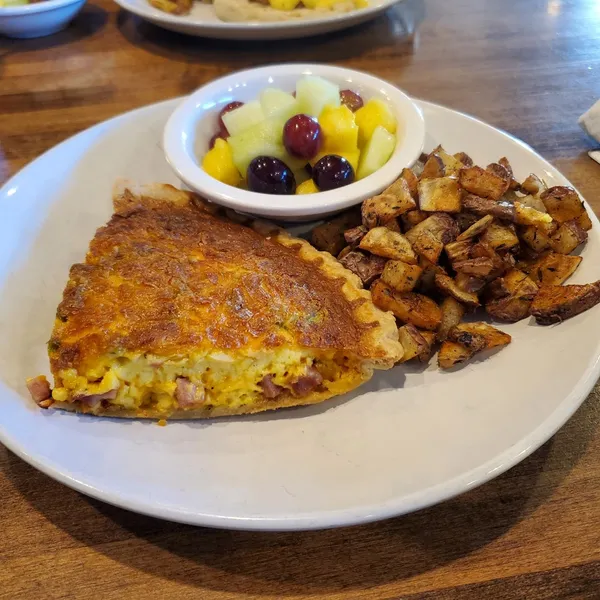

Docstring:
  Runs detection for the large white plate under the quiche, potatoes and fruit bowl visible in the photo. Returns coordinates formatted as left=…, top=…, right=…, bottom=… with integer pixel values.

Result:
left=0, top=100, right=600, bottom=529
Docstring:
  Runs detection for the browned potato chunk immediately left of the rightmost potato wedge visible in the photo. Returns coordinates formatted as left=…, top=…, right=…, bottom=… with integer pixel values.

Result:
left=485, top=269, right=538, bottom=323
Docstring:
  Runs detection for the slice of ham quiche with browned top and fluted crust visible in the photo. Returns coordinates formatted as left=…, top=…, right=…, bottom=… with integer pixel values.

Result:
left=28, top=183, right=403, bottom=418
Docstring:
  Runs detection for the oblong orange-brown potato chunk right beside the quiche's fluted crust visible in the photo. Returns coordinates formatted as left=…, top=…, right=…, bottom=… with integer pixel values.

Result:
left=371, top=279, right=442, bottom=331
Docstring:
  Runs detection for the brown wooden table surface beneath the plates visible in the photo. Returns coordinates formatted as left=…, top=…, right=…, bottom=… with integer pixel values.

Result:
left=0, top=0, right=600, bottom=600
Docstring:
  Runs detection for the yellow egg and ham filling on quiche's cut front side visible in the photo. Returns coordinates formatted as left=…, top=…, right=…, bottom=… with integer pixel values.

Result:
left=52, top=349, right=361, bottom=415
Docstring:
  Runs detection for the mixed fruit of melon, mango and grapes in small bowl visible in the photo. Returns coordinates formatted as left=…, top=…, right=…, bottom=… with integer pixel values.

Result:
left=202, top=76, right=397, bottom=194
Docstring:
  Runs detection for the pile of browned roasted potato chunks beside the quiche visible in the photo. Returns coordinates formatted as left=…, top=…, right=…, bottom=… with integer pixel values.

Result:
left=312, top=146, right=600, bottom=369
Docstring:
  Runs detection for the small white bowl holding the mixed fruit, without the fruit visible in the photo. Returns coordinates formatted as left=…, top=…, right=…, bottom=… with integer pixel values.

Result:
left=163, top=64, right=425, bottom=221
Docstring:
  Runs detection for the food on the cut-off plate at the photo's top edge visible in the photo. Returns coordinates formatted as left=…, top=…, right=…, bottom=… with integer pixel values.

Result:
left=149, top=0, right=369, bottom=23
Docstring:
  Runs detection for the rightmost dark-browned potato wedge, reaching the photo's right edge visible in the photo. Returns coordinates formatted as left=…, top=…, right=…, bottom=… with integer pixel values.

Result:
left=531, top=281, right=600, bottom=325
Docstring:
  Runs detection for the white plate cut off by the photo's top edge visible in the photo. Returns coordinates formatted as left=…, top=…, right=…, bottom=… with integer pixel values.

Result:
left=115, top=0, right=403, bottom=40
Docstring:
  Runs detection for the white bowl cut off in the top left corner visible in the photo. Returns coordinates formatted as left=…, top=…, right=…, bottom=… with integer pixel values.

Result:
left=0, top=0, right=85, bottom=38
